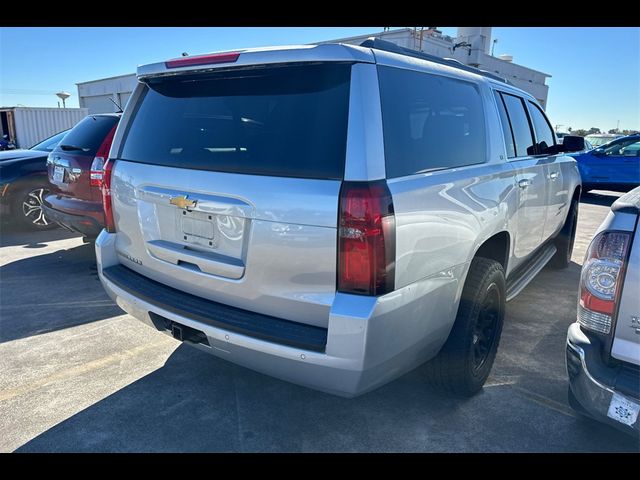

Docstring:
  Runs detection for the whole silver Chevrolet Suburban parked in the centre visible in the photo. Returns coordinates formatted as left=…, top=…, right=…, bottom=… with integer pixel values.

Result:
left=96, top=39, right=582, bottom=396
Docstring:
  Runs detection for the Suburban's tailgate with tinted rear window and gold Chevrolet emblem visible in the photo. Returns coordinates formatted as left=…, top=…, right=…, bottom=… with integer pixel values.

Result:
left=111, top=64, right=351, bottom=327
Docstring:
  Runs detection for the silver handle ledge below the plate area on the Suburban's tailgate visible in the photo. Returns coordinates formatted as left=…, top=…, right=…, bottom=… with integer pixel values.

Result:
left=147, top=240, right=245, bottom=280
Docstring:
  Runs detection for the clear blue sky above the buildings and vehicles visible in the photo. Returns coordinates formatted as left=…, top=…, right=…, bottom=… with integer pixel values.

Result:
left=0, top=27, right=640, bottom=130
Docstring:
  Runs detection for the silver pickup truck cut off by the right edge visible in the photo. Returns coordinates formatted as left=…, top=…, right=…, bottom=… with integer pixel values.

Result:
left=567, top=187, right=640, bottom=438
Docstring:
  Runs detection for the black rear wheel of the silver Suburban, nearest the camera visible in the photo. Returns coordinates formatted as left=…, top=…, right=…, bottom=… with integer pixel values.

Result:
left=425, top=257, right=506, bottom=397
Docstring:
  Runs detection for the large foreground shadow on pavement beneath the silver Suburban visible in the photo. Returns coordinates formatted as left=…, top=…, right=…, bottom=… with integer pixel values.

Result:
left=17, top=256, right=640, bottom=452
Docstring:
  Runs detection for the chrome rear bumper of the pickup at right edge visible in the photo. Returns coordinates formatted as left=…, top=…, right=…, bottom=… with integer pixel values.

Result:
left=567, top=323, right=640, bottom=435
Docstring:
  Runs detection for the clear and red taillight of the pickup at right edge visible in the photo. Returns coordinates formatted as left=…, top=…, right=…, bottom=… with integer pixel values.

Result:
left=578, top=231, right=631, bottom=335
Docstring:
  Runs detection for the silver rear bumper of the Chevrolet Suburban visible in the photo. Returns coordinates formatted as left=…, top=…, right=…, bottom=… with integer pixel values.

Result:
left=96, top=230, right=458, bottom=397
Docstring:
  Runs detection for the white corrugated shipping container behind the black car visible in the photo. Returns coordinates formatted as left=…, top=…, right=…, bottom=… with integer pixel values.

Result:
left=0, top=107, right=89, bottom=148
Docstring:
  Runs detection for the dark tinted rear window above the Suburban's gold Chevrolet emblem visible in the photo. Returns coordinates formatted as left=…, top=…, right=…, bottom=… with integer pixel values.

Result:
left=120, top=64, right=351, bottom=179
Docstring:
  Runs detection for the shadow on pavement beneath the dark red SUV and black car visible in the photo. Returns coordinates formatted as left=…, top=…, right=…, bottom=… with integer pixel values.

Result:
left=0, top=244, right=122, bottom=343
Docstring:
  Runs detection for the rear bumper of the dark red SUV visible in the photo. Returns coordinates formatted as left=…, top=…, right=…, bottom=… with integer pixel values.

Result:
left=42, top=194, right=104, bottom=238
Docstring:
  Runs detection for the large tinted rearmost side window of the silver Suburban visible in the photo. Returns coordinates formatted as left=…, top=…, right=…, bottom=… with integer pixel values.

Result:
left=378, top=63, right=486, bottom=178
